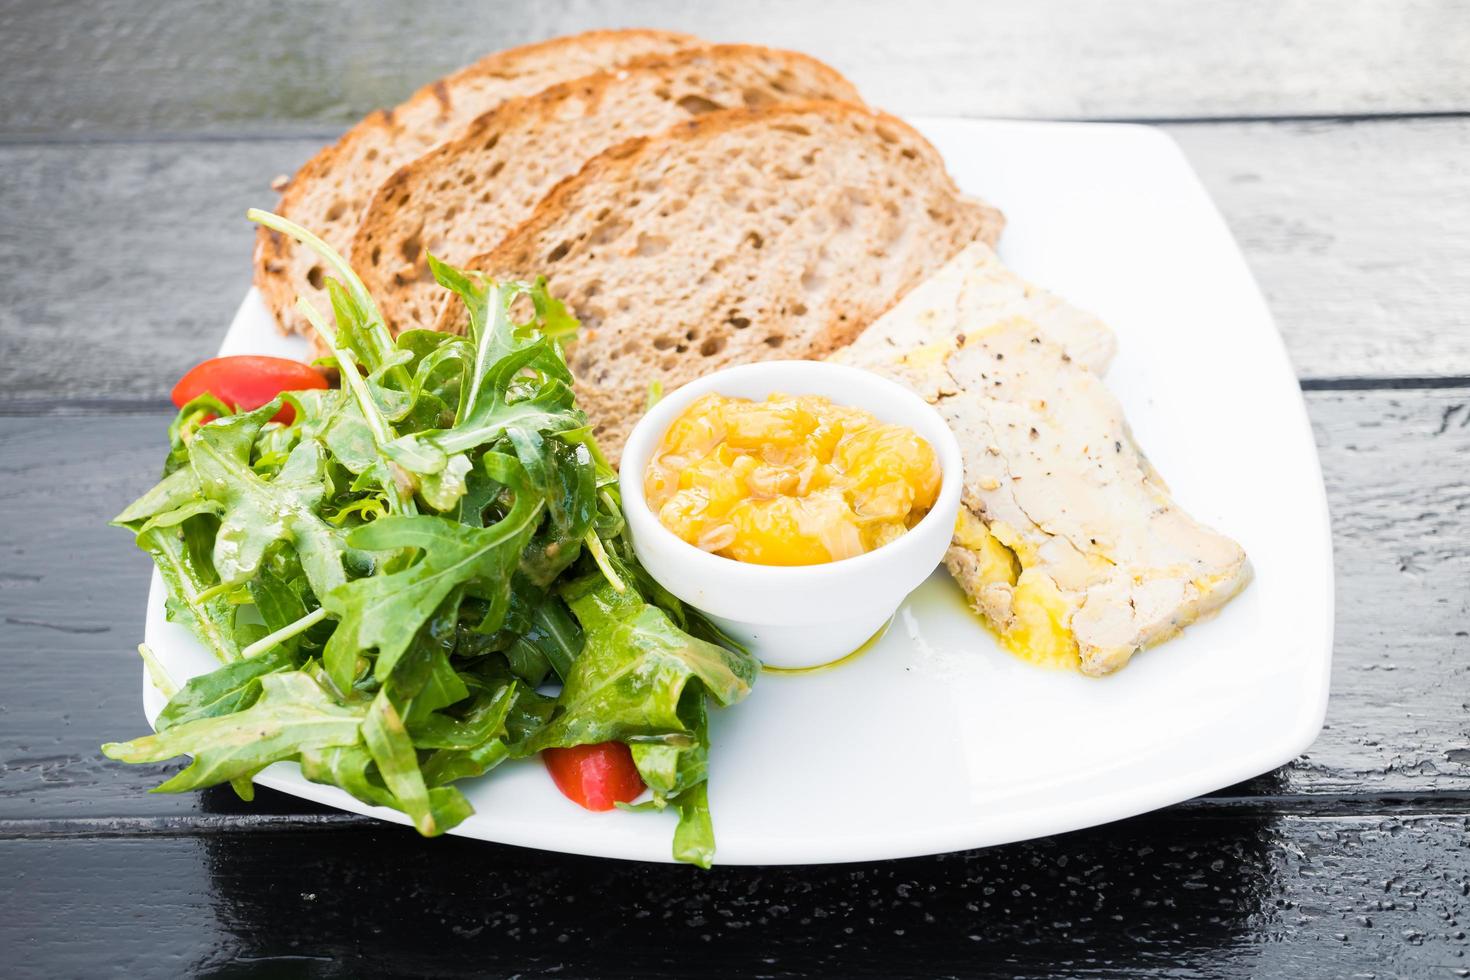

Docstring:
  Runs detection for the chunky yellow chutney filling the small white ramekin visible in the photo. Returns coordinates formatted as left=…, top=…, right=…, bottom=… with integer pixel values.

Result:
left=644, top=394, right=941, bottom=564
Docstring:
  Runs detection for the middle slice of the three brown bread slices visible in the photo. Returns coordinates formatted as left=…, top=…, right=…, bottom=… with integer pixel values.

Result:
left=351, top=44, right=858, bottom=332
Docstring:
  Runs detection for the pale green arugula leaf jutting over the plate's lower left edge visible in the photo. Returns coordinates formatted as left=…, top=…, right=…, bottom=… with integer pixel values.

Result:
left=101, top=671, right=363, bottom=793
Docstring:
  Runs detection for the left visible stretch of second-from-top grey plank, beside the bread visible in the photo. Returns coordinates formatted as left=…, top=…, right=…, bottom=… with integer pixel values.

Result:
left=0, top=141, right=289, bottom=400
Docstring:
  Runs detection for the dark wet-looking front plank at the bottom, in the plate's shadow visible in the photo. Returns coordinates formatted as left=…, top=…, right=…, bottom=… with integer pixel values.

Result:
left=0, top=814, right=1470, bottom=979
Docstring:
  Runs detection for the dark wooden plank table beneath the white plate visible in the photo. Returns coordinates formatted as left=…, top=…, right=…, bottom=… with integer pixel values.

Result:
left=0, top=0, right=1470, bottom=977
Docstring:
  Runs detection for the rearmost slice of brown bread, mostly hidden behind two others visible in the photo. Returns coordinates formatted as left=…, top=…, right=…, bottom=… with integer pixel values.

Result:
left=254, top=31, right=698, bottom=334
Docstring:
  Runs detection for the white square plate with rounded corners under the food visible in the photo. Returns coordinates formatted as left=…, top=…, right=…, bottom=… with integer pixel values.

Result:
left=144, top=119, right=1332, bottom=864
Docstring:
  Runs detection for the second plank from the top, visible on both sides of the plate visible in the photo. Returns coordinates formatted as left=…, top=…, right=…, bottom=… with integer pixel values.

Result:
left=0, top=120, right=1470, bottom=400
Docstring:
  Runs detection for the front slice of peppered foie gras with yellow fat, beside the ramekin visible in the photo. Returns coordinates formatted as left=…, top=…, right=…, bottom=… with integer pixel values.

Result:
left=846, top=313, right=1251, bottom=674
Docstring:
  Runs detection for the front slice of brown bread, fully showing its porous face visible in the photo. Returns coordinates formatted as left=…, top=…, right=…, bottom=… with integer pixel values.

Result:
left=440, top=101, right=1004, bottom=458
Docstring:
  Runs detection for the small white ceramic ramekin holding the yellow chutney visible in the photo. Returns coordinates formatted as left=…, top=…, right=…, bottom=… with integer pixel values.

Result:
left=619, top=360, right=963, bottom=667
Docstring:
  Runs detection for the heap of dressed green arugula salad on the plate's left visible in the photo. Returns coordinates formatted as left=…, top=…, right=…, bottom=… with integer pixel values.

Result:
left=103, top=212, right=759, bottom=867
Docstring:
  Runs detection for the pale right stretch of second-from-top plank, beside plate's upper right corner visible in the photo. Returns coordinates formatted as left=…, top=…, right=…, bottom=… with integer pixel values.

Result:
left=1169, top=117, right=1470, bottom=378
